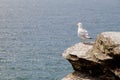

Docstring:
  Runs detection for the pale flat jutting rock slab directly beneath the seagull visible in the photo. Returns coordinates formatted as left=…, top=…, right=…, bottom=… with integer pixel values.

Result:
left=63, top=43, right=93, bottom=60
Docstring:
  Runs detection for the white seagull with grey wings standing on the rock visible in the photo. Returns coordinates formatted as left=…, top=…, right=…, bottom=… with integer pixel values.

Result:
left=77, top=22, right=92, bottom=39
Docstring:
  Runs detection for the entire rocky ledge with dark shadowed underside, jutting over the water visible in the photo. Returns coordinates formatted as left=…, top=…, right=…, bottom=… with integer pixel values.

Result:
left=62, top=32, right=120, bottom=80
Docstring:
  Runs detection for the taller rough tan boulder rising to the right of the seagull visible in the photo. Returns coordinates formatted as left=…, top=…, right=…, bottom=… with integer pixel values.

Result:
left=91, top=32, right=120, bottom=60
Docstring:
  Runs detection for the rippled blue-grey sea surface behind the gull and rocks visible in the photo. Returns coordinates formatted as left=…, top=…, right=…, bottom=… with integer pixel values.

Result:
left=0, top=0, right=120, bottom=80
